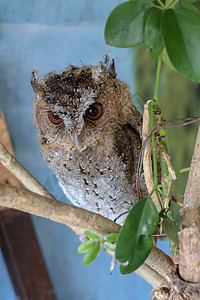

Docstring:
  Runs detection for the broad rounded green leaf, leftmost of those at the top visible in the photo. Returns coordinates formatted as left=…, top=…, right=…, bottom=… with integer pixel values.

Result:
left=105, top=0, right=152, bottom=48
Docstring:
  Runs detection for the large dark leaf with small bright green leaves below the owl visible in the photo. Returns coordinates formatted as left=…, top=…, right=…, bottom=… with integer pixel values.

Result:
left=78, top=198, right=179, bottom=274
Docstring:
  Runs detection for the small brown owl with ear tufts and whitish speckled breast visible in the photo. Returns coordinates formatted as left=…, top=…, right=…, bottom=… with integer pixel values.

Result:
left=31, top=56, right=142, bottom=223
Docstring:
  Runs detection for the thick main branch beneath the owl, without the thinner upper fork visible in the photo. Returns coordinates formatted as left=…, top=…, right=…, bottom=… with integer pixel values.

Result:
left=0, top=185, right=173, bottom=286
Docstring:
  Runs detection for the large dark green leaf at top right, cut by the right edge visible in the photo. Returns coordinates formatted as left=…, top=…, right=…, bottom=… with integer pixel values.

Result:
left=161, top=7, right=200, bottom=82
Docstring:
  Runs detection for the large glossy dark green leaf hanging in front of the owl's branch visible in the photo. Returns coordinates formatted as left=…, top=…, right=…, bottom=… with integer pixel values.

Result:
left=116, top=198, right=159, bottom=274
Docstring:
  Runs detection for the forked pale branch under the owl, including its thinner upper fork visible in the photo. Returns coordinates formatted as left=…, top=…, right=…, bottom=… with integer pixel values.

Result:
left=0, top=144, right=173, bottom=288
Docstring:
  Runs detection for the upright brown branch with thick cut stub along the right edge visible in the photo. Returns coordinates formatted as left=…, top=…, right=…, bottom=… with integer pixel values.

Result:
left=179, top=126, right=200, bottom=283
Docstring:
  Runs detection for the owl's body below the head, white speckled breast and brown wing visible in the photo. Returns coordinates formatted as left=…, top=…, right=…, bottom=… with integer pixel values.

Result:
left=47, top=124, right=141, bottom=222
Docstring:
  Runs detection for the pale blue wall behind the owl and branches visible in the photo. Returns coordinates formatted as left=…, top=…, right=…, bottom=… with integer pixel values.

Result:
left=0, top=0, right=169, bottom=300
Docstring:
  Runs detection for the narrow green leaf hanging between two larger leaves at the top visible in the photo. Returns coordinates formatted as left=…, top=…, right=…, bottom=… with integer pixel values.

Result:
left=144, top=8, right=164, bottom=58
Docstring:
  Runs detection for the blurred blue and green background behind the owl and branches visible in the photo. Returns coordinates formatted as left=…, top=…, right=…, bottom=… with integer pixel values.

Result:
left=0, top=0, right=200, bottom=300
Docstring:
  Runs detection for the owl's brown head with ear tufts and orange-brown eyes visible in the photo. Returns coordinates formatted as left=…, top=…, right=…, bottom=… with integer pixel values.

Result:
left=31, top=56, right=133, bottom=150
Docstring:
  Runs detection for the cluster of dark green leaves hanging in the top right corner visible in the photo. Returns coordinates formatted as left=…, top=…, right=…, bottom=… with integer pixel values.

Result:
left=105, top=0, right=200, bottom=82
